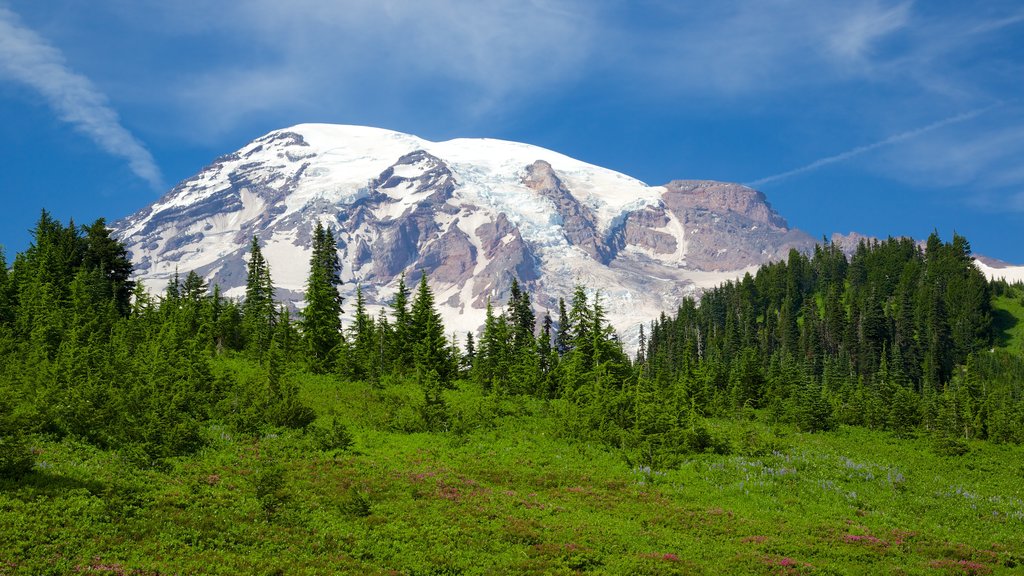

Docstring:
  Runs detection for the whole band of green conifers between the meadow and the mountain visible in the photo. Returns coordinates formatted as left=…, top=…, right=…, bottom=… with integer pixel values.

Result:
left=0, top=211, right=1024, bottom=476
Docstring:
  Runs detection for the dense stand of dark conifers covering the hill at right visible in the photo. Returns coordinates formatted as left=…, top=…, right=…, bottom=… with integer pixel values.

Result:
left=639, top=234, right=1024, bottom=451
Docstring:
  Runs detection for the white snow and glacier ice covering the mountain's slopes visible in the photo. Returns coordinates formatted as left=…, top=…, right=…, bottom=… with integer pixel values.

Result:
left=122, top=124, right=782, bottom=352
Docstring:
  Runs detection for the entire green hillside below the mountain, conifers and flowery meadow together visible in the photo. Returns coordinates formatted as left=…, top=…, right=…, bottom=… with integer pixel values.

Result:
left=0, top=211, right=1024, bottom=574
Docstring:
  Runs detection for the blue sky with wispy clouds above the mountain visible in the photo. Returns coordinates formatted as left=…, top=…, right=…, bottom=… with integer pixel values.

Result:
left=0, top=0, right=1024, bottom=263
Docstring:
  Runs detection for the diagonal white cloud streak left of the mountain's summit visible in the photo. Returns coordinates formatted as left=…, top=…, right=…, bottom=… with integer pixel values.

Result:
left=0, top=6, right=164, bottom=190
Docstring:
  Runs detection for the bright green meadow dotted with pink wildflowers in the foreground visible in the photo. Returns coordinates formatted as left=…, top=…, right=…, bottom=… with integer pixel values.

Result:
left=0, top=366, right=1024, bottom=574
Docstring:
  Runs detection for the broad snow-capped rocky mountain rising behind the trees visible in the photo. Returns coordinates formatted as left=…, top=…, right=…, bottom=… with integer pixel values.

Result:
left=114, top=124, right=814, bottom=342
